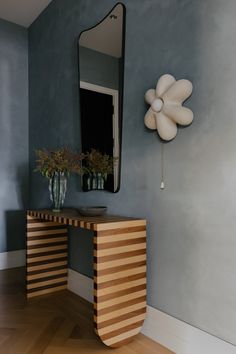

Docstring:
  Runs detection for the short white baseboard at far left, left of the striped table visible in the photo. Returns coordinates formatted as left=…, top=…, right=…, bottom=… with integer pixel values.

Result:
left=0, top=250, right=25, bottom=270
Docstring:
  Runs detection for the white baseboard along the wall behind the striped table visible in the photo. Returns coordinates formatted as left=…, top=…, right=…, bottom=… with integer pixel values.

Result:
left=68, top=269, right=236, bottom=354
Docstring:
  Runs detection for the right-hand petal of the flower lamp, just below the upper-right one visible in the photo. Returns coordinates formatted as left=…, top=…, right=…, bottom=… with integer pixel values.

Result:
left=163, top=104, right=193, bottom=125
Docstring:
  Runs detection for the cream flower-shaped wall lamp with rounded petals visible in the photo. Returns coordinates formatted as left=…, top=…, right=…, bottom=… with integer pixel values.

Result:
left=144, top=74, right=193, bottom=141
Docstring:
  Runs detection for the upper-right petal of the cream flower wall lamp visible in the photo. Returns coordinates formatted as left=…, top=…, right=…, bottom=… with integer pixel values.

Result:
left=162, top=79, right=193, bottom=104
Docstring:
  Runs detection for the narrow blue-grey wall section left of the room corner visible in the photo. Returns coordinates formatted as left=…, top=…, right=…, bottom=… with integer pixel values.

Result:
left=0, top=20, right=28, bottom=252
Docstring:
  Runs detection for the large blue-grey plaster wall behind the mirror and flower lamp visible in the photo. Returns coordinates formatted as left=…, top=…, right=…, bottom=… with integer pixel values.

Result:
left=29, top=0, right=236, bottom=344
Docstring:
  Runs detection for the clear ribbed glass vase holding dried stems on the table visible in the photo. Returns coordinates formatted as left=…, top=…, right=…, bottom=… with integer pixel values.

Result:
left=49, top=172, right=67, bottom=213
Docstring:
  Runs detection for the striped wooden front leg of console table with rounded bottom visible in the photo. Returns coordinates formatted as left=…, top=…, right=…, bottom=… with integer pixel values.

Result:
left=94, top=220, right=146, bottom=347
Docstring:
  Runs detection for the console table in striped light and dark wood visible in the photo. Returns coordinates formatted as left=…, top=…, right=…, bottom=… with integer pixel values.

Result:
left=27, top=210, right=146, bottom=347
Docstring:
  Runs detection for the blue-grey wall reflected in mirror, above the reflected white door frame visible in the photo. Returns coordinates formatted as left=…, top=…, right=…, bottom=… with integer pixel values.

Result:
left=79, top=46, right=119, bottom=90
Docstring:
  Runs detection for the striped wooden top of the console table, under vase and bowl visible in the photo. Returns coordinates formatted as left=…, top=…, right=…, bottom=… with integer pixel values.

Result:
left=27, top=209, right=146, bottom=231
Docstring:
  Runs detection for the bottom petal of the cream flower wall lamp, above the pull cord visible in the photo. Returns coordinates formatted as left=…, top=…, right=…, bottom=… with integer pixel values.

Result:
left=155, top=112, right=177, bottom=141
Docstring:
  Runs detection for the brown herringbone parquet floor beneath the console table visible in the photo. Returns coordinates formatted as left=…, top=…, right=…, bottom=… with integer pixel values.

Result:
left=0, top=268, right=171, bottom=354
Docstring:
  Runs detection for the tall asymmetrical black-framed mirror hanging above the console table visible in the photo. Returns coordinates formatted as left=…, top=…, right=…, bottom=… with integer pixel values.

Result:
left=78, top=3, right=125, bottom=193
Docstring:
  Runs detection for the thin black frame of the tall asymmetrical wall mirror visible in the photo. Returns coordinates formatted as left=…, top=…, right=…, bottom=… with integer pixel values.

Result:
left=77, top=2, right=126, bottom=193
